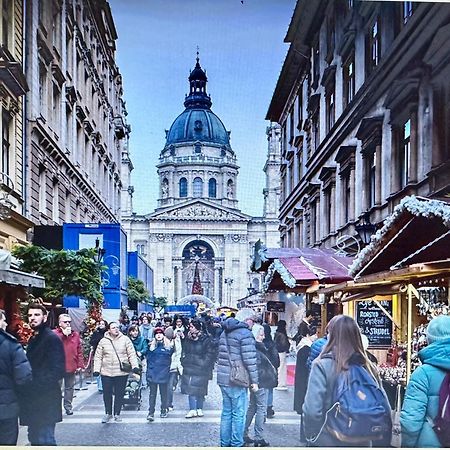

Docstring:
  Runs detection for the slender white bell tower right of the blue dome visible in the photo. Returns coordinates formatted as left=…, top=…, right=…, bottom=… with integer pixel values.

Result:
left=263, top=124, right=281, bottom=219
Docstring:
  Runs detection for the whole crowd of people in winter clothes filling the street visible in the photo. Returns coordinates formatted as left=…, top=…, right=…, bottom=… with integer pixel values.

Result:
left=0, top=304, right=450, bottom=447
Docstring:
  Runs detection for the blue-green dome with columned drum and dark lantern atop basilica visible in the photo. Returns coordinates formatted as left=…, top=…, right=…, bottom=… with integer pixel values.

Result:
left=157, top=53, right=239, bottom=209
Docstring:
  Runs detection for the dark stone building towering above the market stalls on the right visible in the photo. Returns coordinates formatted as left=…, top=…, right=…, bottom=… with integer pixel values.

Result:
left=267, top=0, right=450, bottom=251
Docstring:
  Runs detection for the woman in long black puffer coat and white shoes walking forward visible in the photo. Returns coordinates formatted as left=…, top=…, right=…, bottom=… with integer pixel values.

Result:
left=181, top=319, right=216, bottom=419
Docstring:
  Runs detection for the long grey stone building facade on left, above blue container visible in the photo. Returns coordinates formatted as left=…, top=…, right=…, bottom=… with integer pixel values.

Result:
left=24, top=0, right=131, bottom=225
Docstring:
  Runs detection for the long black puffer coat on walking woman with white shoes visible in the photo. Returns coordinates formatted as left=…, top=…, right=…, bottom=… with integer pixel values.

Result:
left=181, top=334, right=216, bottom=397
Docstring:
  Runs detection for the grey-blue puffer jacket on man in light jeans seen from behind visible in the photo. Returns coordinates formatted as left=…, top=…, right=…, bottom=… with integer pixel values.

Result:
left=217, top=317, right=258, bottom=386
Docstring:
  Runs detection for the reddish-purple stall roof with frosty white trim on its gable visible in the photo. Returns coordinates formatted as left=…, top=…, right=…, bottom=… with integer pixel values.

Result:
left=263, top=248, right=353, bottom=292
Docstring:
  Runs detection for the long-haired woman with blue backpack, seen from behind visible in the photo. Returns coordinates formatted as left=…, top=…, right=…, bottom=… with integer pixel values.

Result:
left=303, top=315, right=392, bottom=447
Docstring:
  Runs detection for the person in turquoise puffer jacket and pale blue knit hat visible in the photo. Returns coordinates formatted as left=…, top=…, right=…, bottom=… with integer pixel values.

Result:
left=400, top=316, right=450, bottom=447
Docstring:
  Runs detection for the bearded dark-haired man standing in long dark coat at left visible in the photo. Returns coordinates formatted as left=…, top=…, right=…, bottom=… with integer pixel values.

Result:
left=20, top=303, right=65, bottom=446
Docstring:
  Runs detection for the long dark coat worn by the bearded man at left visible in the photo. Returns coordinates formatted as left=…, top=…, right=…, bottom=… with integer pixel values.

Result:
left=20, top=325, right=65, bottom=426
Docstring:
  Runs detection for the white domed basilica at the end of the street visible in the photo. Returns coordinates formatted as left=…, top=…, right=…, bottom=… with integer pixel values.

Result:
left=122, top=58, right=280, bottom=306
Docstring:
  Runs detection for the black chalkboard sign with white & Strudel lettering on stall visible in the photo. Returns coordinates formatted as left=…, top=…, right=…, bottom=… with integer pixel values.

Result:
left=356, top=300, right=392, bottom=347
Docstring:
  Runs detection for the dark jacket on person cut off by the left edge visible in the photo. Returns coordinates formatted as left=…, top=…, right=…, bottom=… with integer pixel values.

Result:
left=0, top=329, right=31, bottom=420
